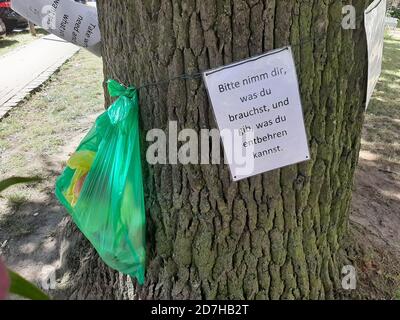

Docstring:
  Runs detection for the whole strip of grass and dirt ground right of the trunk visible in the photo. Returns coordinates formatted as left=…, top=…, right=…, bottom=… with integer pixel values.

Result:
left=349, top=32, right=400, bottom=300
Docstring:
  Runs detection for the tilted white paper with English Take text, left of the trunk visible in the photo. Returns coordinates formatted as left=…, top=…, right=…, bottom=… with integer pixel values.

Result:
left=11, top=0, right=101, bottom=56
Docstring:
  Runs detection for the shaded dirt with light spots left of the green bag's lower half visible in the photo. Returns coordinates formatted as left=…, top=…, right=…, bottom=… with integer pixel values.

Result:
left=0, top=152, right=67, bottom=289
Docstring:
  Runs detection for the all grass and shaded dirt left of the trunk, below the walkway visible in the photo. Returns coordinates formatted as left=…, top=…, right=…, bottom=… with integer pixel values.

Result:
left=0, top=52, right=104, bottom=296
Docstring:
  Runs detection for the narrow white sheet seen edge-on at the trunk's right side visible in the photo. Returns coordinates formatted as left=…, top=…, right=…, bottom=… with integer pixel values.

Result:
left=365, top=0, right=386, bottom=107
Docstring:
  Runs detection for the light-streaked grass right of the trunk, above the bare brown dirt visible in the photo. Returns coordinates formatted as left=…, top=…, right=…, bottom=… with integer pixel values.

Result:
left=362, top=37, right=400, bottom=165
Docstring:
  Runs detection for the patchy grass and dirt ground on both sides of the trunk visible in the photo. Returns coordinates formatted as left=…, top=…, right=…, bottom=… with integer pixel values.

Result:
left=0, top=39, right=400, bottom=299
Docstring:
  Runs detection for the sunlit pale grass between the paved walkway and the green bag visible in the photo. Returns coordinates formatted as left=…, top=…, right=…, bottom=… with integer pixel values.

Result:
left=0, top=50, right=104, bottom=208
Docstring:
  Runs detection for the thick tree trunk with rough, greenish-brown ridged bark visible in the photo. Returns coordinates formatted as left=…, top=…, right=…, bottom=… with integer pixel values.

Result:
left=60, top=0, right=369, bottom=299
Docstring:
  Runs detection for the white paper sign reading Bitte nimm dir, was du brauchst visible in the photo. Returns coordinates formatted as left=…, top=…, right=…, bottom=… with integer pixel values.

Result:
left=203, top=47, right=310, bottom=181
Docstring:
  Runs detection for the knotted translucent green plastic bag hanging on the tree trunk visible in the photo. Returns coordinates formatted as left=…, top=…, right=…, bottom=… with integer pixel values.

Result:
left=56, top=80, right=146, bottom=284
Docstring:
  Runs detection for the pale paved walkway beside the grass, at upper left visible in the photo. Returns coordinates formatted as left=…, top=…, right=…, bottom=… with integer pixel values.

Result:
left=0, top=35, right=79, bottom=119
